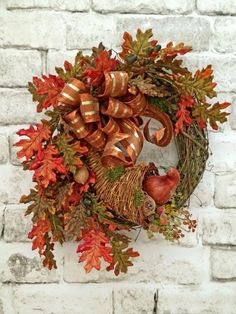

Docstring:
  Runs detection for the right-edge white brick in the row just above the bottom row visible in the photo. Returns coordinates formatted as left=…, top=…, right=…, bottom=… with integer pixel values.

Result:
left=211, top=249, right=236, bottom=280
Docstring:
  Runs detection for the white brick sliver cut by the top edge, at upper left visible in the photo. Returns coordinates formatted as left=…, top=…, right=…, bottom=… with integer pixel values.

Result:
left=7, top=0, right=89, bottom=12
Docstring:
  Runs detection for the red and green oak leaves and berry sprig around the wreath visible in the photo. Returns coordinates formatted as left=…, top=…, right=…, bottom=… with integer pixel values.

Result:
left=15, top=29, right=229, bottom=275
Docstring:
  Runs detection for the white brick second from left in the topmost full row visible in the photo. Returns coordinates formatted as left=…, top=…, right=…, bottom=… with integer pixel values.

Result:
left=66, top=13, right=118, bottom=49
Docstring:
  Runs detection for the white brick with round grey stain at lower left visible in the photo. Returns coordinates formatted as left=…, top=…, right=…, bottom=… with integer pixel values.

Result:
left=0, top=243, right=60, bottom=283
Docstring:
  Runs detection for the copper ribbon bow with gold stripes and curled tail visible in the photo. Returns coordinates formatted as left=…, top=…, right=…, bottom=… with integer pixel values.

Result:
left=58, top=71, right=173, bottom=167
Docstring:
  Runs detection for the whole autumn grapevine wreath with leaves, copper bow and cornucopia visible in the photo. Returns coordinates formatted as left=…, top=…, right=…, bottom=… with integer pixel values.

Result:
left=15, top=29, right=229, bottom=275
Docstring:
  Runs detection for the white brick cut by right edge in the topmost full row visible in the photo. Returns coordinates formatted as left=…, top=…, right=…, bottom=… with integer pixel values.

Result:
left=213, top=17, right=236, bottom=52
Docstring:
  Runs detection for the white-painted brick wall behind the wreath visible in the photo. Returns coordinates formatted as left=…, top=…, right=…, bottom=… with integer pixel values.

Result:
left=0, top=0, right=236, bottom=314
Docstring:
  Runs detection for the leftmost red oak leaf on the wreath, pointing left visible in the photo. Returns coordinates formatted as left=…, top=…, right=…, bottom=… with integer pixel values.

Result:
left=14, top=123, right=51, bottom=160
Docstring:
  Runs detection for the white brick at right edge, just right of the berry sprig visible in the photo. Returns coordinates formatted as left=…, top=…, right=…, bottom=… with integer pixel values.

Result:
left=202, top=213, right=236, bottom=245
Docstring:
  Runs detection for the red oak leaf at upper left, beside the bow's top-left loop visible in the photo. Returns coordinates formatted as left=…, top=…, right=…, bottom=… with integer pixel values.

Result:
left=33, top=74, right=64, bottom=112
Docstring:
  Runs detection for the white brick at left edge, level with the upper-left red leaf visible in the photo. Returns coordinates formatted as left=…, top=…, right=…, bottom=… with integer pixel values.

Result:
left=0, top=88, right=40, bottom=125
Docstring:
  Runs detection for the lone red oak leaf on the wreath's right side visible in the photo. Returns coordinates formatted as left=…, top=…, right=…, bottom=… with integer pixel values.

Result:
left=175, top=96, right=194, bottom=135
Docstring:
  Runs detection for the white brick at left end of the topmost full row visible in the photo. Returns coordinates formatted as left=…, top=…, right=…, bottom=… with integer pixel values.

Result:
left=0, top=11, right=66, bottom=49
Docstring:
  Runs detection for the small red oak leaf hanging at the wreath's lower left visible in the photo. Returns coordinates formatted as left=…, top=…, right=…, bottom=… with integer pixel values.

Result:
left=28, top=219, right=51, bottom=256
